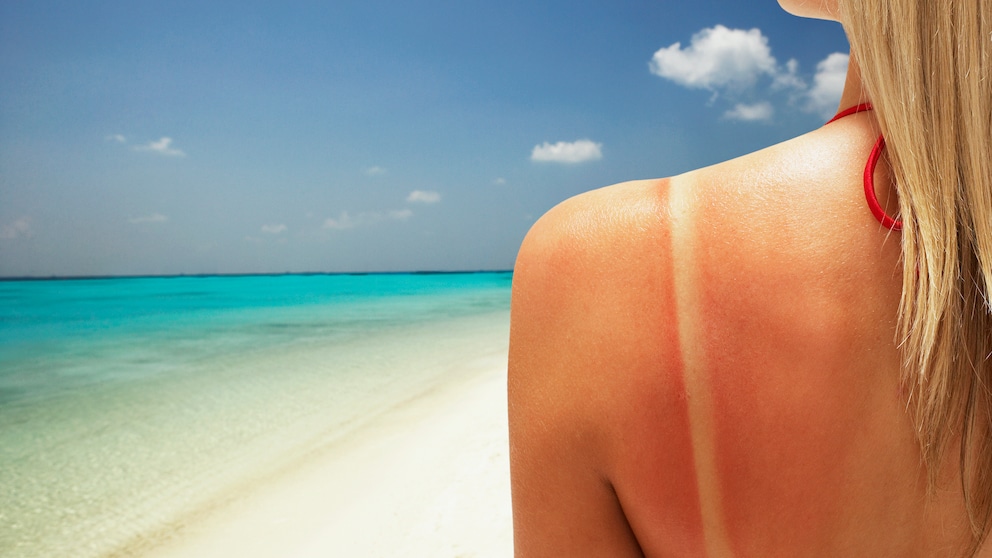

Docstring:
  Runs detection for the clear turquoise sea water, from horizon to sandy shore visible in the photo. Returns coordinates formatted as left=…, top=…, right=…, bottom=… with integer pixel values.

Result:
left=0, top=273, right=511, bottom=556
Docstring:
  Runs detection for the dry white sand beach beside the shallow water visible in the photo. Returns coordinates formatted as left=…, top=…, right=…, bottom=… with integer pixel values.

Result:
left=142, top=355, right=512, bottom=558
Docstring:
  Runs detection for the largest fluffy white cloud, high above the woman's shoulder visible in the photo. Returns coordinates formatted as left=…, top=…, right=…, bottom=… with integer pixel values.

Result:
left=650, top=25, right=778, bottom=90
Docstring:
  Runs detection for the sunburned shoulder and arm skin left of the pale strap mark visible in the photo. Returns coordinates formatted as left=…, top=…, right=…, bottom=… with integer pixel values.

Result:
left=509, top=181, right=704, bottom=556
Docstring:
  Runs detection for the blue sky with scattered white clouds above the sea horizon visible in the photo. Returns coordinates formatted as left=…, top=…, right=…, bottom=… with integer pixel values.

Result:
left=0, top=0, right=848, bottom=276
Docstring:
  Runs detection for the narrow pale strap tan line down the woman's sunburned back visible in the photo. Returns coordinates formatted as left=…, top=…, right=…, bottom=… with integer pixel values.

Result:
left=668, top=176, right=733, bottom=558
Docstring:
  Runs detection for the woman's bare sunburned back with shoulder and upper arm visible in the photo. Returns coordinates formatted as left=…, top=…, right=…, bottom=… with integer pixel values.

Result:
left=509, top=109, right=984, bottom=557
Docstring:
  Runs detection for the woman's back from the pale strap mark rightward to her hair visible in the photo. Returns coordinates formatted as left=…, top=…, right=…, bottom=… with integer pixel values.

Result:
left=670, top=116, right=961, bottom=557
